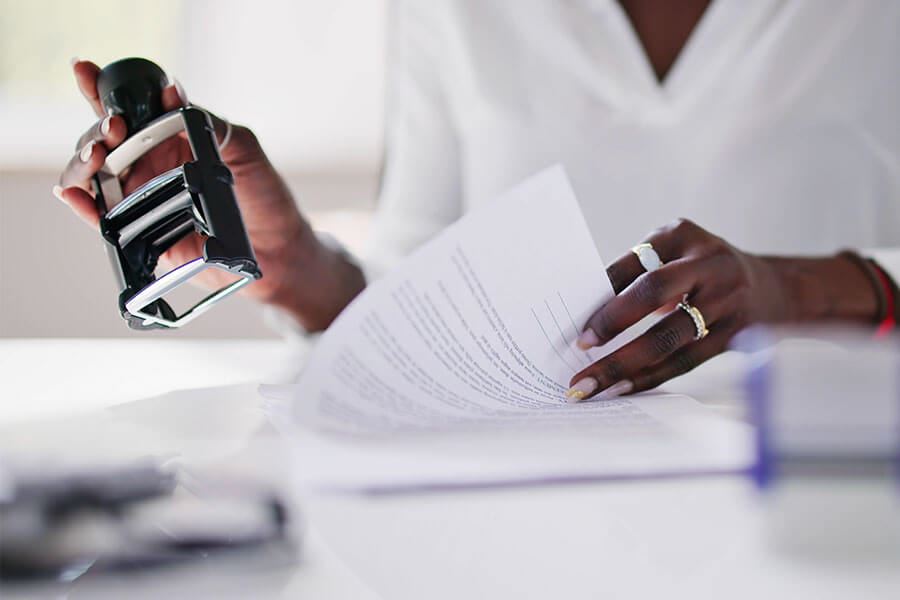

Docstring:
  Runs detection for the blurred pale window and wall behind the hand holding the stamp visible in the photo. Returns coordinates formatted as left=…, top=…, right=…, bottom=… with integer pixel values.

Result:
left=0, top=0, right=386, bottom=337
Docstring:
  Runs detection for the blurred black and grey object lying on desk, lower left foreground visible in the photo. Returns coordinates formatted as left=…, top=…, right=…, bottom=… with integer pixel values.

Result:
left=0, top=462, right=293, bottom=583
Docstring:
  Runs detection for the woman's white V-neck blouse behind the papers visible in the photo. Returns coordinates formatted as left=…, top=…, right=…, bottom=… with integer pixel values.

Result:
left=366, top=0, right=900, bottom=281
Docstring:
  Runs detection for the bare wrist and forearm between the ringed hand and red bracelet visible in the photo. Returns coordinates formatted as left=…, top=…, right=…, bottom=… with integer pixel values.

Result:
left=760, top=255, right=880, bottom=323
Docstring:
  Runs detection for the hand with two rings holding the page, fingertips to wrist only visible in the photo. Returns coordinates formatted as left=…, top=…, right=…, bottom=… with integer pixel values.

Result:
left=567, top=220, right=753, bottom=402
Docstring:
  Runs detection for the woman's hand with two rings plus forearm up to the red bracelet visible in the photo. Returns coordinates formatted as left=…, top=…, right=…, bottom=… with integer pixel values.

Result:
left=569, top=220, right=878, bottom=401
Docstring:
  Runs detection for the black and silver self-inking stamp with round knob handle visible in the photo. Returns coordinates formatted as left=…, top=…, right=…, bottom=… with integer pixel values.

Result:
left=94, top=58, right=262, bottom=330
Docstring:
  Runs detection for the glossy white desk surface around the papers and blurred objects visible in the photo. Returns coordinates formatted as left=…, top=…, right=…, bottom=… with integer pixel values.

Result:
left=0, top=340, right=900, bottom=600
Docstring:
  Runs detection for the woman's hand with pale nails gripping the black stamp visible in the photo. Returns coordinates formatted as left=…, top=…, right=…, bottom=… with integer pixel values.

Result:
left=53, top=61, right=364, bottom=330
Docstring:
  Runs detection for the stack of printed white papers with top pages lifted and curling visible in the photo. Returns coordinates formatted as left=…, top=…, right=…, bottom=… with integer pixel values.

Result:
left=264, top=167, right=744, bottom=492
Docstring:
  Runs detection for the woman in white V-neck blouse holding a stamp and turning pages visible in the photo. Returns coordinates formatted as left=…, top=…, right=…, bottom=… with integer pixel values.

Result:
left=54, top=0, right=900, bottom=399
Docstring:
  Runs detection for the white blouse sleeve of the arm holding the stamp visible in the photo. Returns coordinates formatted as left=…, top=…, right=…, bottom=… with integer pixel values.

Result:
left=362, top=0, right=461, bottom=281
